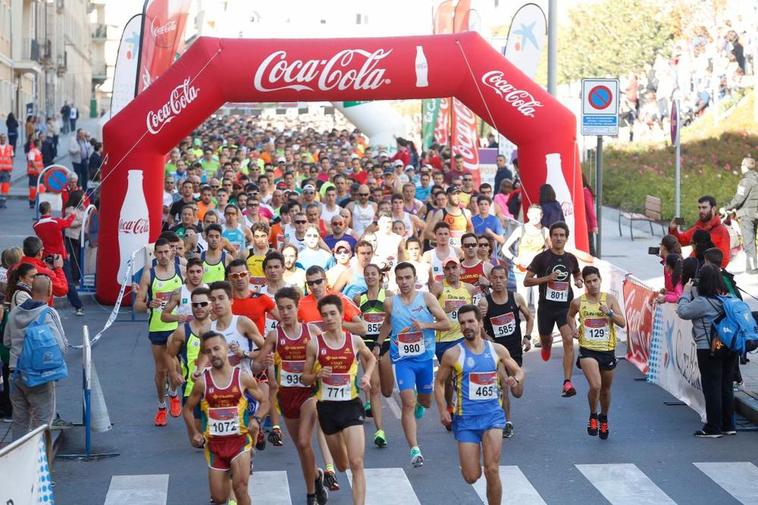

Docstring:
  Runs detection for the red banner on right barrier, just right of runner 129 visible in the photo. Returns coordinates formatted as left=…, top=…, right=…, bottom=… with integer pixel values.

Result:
left=624, top=277, right=656, bottom=373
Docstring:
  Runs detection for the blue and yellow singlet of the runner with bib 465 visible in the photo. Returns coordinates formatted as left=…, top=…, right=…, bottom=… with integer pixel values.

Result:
left=453, top=340, right=501, bottom=416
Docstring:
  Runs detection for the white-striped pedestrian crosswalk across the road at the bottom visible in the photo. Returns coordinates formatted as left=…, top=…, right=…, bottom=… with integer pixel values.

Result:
left=104, top=462, right=758, bottom=505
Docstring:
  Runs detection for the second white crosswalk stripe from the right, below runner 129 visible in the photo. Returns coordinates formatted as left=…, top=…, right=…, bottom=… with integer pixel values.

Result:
left=575, top=463, right=676, bottom=505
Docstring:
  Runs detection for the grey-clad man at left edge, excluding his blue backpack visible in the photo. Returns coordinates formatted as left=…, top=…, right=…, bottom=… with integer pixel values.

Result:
left=3, top=275, right=67, bottom=440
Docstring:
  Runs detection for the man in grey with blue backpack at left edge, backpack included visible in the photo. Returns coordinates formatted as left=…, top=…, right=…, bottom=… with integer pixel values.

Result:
left=3, top=275, right=68, bottom=440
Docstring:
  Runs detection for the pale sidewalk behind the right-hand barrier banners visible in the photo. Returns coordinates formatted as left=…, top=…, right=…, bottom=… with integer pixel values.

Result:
left=602, top=203, right=758, bottom=424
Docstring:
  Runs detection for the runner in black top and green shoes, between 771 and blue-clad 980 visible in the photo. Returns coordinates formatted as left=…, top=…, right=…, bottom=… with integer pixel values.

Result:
left=353, top=264, right=392, bottom=449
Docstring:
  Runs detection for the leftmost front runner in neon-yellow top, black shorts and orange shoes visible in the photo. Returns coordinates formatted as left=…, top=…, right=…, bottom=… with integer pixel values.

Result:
left=134, top=238, right=182, bottom=426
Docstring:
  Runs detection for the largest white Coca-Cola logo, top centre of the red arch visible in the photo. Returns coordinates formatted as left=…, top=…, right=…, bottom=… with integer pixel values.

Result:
left=253, top=49, right=392, bottom=93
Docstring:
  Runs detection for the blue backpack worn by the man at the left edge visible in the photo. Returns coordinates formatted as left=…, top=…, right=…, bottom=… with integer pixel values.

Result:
left=15, top=309, right=68, bottom=388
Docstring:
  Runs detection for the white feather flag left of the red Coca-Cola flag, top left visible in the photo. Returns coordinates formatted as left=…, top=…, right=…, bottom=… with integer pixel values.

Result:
left=111, top=14, right=142, bottom=117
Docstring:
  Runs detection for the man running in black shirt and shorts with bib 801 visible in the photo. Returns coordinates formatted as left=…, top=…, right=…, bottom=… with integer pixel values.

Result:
left=524, top=221, right=582, bottom=398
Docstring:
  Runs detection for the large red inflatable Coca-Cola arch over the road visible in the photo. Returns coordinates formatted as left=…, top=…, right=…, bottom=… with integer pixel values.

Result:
left=96, top=32, right=587, bottom=304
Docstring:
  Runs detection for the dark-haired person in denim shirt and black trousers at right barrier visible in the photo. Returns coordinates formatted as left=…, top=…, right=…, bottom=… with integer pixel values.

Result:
left=676, top=265, right=737, bottom=438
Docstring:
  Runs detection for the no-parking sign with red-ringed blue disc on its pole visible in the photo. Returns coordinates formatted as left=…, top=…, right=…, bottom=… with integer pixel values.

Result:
left=582, top=79, right=619, bottom=258
